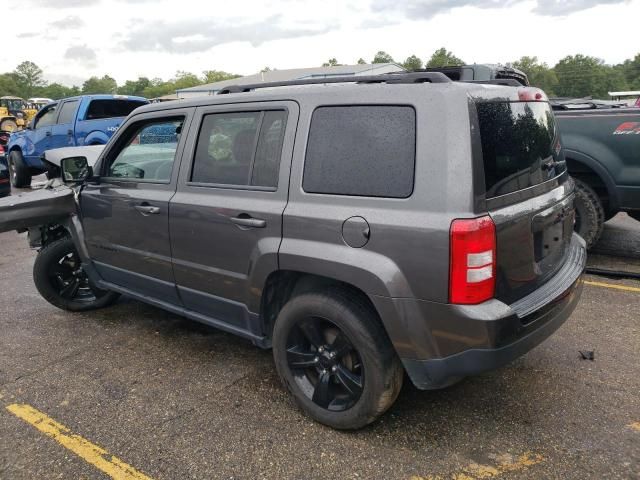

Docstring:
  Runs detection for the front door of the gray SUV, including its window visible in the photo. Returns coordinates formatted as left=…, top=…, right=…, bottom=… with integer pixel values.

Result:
left=80, top=109, right=192, bottom=304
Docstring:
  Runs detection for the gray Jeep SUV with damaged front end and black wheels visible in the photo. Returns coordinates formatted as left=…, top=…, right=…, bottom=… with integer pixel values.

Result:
left=0, top=72, right=585, bottom=429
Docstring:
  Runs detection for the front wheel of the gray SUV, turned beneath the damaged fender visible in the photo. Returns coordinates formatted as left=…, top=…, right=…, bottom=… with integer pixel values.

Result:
left=33, top=237, right=119, bottom=312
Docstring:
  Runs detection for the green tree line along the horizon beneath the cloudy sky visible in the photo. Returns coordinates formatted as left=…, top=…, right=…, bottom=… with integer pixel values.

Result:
left=0, top=48, right=640, bottom=99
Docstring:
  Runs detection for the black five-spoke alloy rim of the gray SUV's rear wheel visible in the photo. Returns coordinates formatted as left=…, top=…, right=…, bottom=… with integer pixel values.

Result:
left=287, top=317, right=365, bottom=412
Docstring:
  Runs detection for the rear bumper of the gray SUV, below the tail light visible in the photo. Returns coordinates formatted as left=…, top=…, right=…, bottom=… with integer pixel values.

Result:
left=401, top=234, right=586, bottom=389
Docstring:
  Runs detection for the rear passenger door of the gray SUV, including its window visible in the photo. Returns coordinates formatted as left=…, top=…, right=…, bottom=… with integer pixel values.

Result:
left=169, top=101, right=298, bottom=333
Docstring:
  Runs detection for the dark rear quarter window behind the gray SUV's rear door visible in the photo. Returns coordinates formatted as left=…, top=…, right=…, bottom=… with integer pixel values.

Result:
left=302, top=105, right=416, bottom=198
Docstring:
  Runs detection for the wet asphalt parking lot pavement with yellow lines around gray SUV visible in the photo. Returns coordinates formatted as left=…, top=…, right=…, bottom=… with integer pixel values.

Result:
left=0, top=217, right=640, bottom=480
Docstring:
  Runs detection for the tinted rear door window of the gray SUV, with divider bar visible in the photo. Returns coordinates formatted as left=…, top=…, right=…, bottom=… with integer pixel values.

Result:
left=191, top=110, right=286, bottom=187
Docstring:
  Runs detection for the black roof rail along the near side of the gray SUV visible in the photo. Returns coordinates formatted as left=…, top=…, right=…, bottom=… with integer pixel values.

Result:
left=218, top=72, right=451, bottom=95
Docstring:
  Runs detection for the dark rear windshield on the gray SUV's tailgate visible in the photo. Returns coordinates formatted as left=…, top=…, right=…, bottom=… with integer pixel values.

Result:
left=476, top=102, right=565, bottom=198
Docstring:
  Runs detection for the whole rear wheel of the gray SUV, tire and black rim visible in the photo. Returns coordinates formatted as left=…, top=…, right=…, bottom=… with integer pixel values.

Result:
left=273, top=289, right=404, bottom=429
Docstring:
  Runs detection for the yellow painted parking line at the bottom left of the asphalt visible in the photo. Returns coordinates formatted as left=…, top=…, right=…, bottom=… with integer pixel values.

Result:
left=6, top=403, right=152, bottom=480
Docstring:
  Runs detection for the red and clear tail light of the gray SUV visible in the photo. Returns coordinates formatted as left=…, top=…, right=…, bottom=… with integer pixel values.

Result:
left=449, top=216, right=496, bottom=305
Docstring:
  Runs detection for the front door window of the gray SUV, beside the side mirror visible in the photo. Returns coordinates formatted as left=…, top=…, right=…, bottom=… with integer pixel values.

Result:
left=107, top=117, right=184, bottom=182
